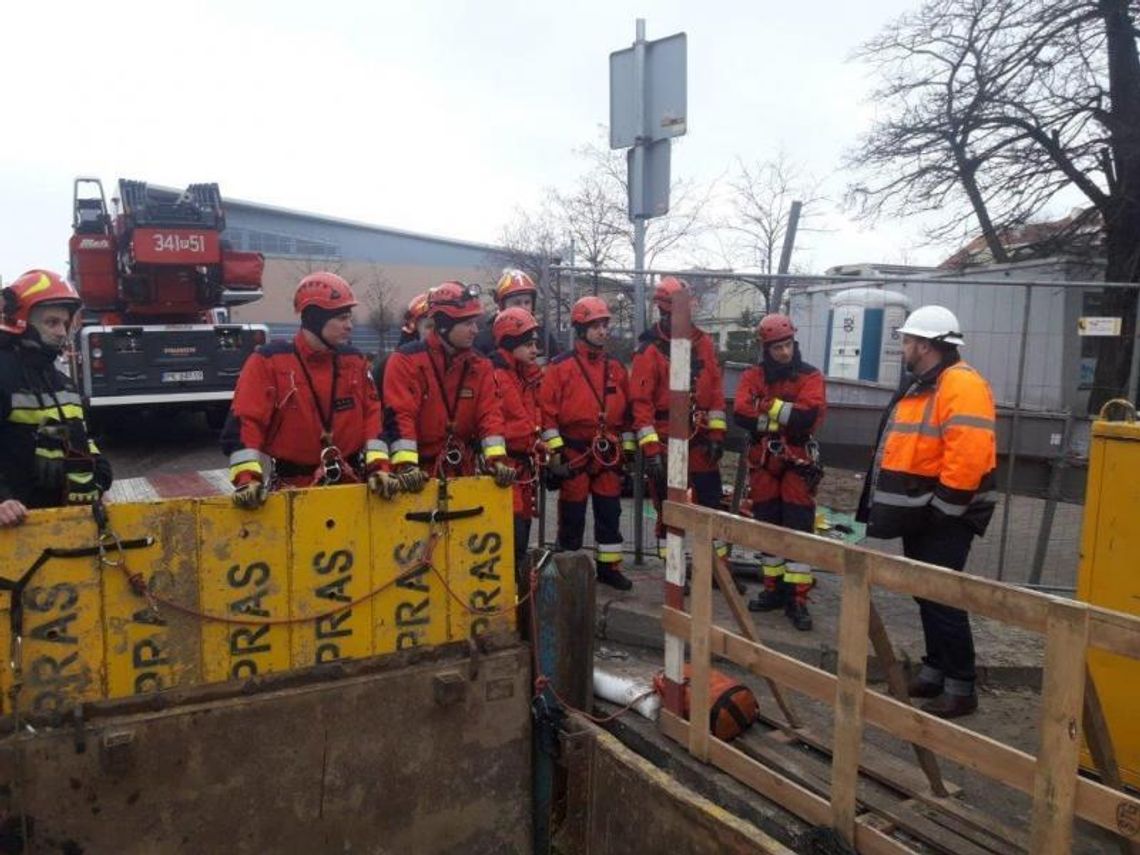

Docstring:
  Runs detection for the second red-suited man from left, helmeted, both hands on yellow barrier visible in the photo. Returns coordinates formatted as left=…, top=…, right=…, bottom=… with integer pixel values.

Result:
left=384, top=282, right=514, bottom=491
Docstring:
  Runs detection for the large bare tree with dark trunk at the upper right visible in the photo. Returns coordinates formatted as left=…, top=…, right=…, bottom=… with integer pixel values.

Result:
left=848, top=0, right=1140, bottom=406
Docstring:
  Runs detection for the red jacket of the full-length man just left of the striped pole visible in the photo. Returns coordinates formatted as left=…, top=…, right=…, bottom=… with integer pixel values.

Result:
left=538, top=341, right=634, bottom=451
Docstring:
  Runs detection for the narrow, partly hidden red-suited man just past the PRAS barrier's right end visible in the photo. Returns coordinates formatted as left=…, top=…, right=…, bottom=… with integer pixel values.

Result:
left=490, top=307, right=543, bottom=589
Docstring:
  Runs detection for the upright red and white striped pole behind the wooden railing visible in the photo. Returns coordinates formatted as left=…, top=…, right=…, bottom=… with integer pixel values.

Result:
left=662, top=291, right=692, bottom=716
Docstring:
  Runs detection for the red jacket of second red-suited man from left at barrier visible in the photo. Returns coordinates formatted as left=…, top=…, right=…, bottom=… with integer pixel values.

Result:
left=384, top=332, right=506, bottom=478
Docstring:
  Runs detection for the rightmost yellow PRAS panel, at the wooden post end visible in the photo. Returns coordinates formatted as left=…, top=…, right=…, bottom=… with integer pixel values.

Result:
left=446, top=477, right=515, bottom=641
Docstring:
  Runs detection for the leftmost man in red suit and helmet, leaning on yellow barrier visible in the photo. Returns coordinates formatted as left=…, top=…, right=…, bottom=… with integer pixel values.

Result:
left=222, top=272, right=397, bottom=508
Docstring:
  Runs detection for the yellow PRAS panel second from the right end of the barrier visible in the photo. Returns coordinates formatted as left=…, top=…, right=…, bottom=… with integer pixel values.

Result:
left=368, top=481, right=448, bottom=654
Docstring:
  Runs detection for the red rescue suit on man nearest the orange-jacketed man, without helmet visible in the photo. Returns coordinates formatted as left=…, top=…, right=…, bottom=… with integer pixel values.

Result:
left=733, top=345, right=828, bottom=551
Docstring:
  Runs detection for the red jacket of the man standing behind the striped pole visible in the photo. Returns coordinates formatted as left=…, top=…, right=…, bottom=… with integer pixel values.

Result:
left=629, top=324, right=727, bottom=455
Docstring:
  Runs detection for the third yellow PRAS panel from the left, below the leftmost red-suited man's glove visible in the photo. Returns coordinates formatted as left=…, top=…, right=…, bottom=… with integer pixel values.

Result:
left=198, top=491, right=293, bottom=682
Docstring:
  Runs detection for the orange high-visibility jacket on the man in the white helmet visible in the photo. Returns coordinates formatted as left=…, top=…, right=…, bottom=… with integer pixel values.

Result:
left=863, top=360, right=998, bottom=537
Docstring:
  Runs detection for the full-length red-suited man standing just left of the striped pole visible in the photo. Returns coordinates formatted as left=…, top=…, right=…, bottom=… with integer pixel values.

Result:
left=538, top=296, right=636, bottom=591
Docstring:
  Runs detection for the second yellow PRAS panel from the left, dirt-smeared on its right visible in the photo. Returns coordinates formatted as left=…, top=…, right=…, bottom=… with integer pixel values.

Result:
left=103, top=499, right=202, bottom=698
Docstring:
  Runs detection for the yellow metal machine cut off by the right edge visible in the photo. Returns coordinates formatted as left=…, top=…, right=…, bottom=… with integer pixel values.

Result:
left=1077, top=405, right=1140, bottom=788
